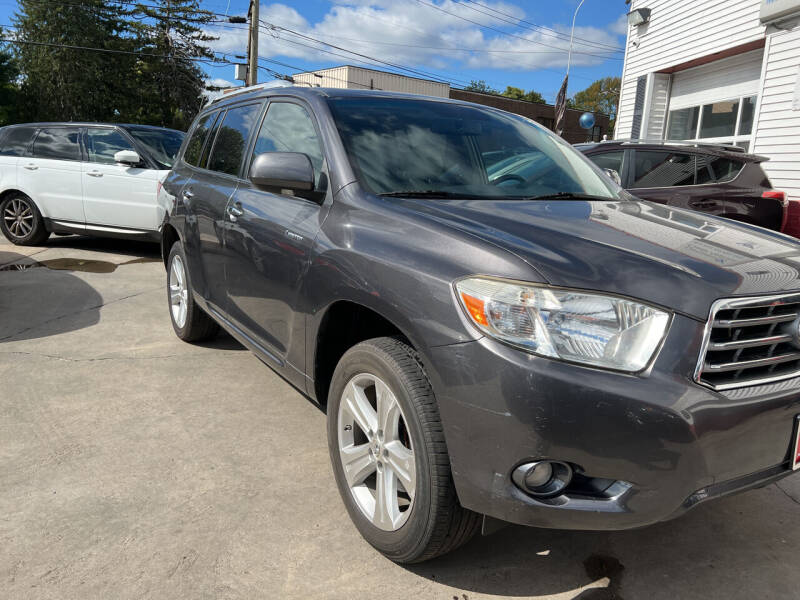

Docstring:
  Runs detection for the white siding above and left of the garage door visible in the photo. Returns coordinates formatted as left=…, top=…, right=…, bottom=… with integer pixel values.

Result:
left=616, top=0, right=764, bottom=138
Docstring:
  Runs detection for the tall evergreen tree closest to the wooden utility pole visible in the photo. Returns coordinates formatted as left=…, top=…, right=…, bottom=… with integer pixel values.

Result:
left=133, top=0, right=215, bottom=129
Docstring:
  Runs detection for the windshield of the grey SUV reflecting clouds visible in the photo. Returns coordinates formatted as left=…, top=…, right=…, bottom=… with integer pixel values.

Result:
left=328, top=96, right=620, bottom=199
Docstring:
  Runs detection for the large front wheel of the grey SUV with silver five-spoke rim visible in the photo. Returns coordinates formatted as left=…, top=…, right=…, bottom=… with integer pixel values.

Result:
left=328, top=338, right=480, bottom=563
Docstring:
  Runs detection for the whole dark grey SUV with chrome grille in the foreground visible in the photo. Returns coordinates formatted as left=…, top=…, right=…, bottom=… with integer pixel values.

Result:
left=162, top=88, right=800, bottom=562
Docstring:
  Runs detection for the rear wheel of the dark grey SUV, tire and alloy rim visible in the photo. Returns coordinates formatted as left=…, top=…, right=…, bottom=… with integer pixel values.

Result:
left=167, top=242, right=219, bottom=342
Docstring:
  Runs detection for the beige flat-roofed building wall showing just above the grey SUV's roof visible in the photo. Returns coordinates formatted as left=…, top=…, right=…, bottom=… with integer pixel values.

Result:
left=293, top=65, right=450, bottom=98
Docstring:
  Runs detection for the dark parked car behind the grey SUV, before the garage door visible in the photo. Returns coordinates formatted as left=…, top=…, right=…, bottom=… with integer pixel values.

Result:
left=575, top=140, right=788, bottom=233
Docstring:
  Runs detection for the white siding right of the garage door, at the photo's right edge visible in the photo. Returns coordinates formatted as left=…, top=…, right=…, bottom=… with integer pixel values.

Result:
left=753, top=27, right=800, bottom=200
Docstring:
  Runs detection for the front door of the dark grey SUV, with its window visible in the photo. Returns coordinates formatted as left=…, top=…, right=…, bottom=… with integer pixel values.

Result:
left=225, top=101, right=327, bottom=370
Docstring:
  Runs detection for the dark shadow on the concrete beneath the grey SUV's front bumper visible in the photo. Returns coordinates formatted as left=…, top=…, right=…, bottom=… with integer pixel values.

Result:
left=409, top=485, right=800, bottom=600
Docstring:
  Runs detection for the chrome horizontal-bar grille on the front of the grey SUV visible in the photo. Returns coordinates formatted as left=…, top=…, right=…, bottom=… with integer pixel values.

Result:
left=695, top=294, right=800, bottom=390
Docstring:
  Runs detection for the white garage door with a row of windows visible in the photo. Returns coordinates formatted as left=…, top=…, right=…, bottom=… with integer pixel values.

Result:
left=666, top=50, right=764, bottom=148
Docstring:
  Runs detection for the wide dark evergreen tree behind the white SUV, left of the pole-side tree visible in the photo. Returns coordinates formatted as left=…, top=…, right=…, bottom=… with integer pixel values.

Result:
left=12, top=0, right=134, bottom=121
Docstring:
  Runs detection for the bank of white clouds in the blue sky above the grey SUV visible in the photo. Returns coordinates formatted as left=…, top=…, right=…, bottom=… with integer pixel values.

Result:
left=212, top=0, right=627, bottom=84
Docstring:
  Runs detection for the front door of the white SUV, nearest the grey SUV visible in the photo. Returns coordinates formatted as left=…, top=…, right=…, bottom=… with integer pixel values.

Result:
left=81, top=127, right=160, bottom=231
